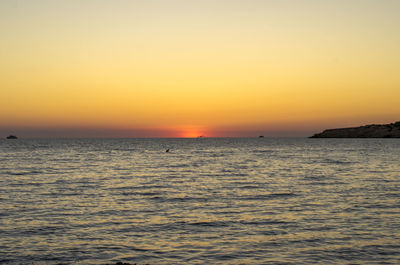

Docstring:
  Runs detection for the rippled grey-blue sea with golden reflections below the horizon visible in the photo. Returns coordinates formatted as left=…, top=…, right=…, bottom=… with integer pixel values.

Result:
left=0, top=138, right=400, bottom=264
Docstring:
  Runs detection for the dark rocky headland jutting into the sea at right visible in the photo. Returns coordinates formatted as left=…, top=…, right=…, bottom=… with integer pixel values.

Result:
left=310, top=121, right=400, bottom=138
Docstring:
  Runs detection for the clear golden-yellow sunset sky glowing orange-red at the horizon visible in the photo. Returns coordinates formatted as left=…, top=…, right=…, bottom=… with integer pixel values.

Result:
left=0, top=0, right=400, bottom=137
